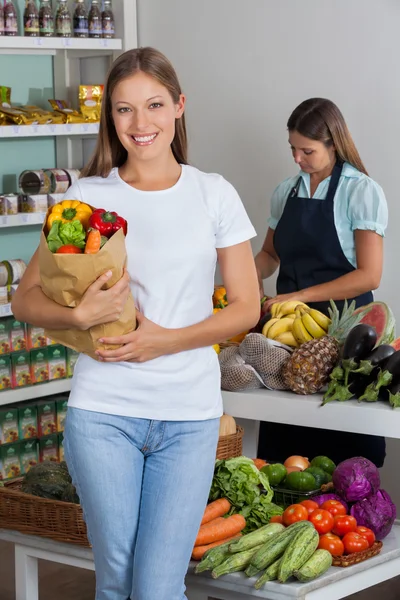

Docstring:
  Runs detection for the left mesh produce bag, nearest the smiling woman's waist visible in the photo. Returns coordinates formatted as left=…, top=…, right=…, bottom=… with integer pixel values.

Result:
left=219, top=346, right=264, bottom=392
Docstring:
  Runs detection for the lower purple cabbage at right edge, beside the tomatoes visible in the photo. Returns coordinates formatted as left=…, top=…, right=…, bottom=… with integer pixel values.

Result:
left=350, top=490, right=396, bottom=540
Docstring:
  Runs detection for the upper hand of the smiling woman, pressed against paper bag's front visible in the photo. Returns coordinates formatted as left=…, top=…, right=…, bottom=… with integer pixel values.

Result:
left=73, top=271, right=130, bottom=330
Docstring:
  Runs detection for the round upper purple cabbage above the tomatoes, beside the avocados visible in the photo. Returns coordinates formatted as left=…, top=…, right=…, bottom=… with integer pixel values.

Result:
left=332, top=456, right=381, bottom=502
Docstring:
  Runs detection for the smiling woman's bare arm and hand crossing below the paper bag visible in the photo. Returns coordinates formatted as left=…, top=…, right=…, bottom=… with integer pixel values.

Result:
left=97, top=242, right=260, bottom=362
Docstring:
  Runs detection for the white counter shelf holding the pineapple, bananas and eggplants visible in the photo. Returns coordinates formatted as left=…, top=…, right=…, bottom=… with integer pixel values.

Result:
left=222, top=390, right=400, bottom=439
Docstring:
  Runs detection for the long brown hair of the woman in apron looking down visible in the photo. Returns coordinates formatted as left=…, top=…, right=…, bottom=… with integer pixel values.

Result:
left=287, top=98, right=368, bottom=175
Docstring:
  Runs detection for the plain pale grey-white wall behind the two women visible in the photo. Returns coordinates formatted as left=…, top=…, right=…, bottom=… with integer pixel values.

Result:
left=138, top=0, right=400, bottom=506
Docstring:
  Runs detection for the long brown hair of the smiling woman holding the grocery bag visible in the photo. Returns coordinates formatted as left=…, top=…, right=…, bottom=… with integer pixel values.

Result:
left=81, top=47, right=187, bottom=177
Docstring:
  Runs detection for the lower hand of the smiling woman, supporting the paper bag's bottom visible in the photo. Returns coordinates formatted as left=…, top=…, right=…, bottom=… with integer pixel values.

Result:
left=96, top=312, right=175, bottom=362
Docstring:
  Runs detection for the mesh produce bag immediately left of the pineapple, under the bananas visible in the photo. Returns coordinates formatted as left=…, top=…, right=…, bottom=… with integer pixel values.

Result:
left=239, top=333, right=290, bottom=390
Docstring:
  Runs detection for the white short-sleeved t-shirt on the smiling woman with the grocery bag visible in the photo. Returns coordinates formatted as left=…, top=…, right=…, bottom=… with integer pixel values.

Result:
left=65, top=165, right=256, bottom=421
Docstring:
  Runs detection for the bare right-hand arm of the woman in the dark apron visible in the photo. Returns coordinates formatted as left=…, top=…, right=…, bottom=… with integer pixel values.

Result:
left=266, top=229, right=383, bottom=308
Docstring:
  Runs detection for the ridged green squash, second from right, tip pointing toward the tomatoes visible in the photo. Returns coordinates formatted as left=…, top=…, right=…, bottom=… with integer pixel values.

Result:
left=278, top=526, right=319, bottom=583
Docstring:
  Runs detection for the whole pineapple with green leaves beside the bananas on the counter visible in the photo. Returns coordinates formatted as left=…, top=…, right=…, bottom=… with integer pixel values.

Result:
left=282, top=300, right=362, bottom=394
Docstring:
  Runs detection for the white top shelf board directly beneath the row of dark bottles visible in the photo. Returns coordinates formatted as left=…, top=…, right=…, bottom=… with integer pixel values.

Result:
left=0, top=36, right=122, bottom=54
